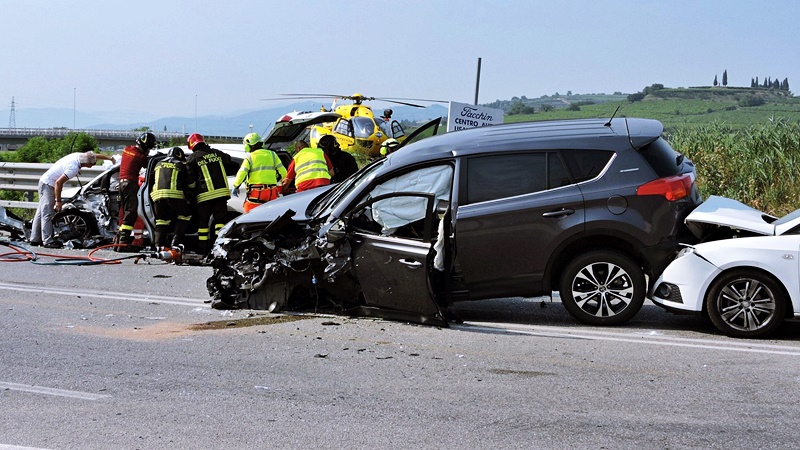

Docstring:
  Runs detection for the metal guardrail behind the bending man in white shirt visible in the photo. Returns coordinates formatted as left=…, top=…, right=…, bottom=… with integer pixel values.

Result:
left=0, top=162, right=106, bottom=209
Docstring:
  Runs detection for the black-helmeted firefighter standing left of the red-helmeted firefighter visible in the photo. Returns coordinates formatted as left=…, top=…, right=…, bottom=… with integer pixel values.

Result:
left=150, top=147, right=194, bottom=249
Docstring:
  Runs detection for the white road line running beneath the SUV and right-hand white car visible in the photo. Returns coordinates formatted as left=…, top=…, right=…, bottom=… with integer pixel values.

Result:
left=460, top=322, right=800, bottom=356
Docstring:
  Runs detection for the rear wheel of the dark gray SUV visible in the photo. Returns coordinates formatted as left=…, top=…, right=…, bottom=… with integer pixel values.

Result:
left=559, top=250, right=647, bottom=325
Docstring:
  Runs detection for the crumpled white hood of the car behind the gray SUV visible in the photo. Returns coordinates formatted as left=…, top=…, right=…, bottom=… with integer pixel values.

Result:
left=685, top=195, right=776, bottom=238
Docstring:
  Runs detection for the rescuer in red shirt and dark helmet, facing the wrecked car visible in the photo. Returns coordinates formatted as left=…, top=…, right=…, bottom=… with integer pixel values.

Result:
left=114, top=133, right=156, bottom=246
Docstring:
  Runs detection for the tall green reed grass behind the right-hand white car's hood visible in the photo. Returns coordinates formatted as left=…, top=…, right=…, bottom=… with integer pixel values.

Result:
left=666, top=119, right=800, bottom=216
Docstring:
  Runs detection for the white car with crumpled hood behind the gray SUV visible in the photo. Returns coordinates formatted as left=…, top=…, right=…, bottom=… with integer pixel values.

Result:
left=651, top=196, right=800, bottom=338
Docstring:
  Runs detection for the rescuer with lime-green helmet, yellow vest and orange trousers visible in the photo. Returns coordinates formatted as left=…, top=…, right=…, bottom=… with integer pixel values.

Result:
left=231, top=133, right=286, bottom=212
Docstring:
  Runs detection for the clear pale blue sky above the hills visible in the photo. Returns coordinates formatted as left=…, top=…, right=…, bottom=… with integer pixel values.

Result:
left=0, top=0, right=800, bottom=119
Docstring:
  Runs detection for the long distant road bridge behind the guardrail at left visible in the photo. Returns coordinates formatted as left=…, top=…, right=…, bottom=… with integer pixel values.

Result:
left=0, top=128, right=242, bottom=151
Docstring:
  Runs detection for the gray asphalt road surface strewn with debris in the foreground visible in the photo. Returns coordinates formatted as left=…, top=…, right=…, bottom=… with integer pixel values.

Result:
left=0, top=246, right=800, bottom=449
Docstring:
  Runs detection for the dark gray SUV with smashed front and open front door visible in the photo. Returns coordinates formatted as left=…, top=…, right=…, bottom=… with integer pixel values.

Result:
left=207, top=118, right=701, bottom=325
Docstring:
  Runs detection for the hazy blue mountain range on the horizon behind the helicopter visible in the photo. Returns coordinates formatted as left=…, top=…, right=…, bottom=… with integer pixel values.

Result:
left=10, top=102, right=447, bottom=136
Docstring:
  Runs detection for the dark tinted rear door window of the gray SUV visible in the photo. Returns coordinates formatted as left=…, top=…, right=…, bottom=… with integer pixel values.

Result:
left=467, top=152, right=571, bottom=204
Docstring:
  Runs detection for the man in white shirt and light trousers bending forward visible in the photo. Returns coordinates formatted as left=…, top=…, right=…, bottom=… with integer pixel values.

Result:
left=30, top=152, right=110, bottom=248
